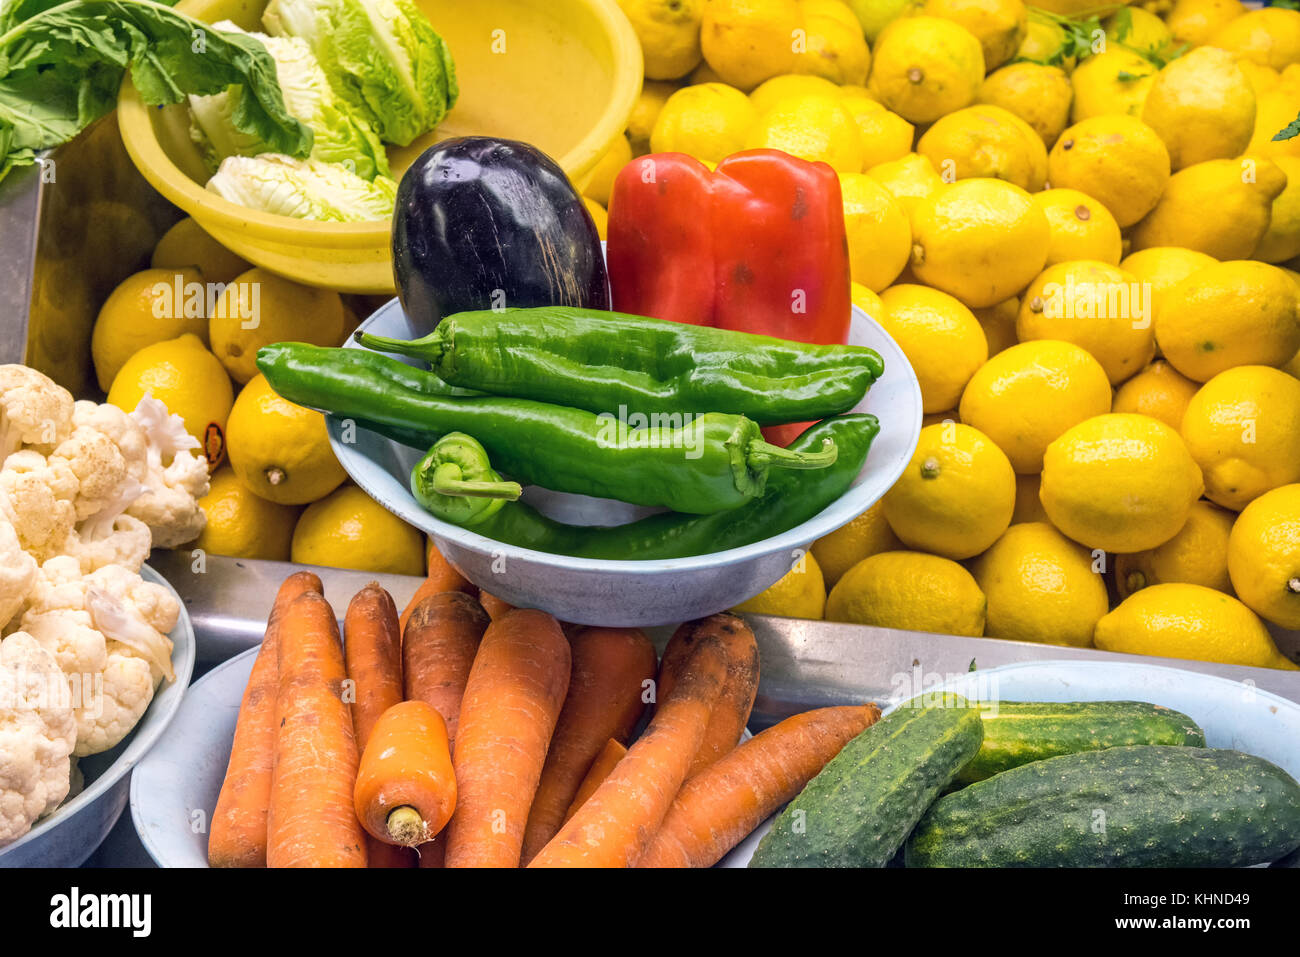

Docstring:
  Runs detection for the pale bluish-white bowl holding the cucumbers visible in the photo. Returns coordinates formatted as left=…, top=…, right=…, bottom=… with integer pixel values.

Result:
left=719, top=661, right=1300, bottom=867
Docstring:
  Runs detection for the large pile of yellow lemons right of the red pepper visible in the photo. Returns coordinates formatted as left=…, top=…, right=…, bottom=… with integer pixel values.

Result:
left=613, top=0, right=1300, bottom=667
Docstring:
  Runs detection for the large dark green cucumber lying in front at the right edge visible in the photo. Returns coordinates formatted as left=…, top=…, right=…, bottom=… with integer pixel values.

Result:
left=905, top=745, right=1300, bottom=867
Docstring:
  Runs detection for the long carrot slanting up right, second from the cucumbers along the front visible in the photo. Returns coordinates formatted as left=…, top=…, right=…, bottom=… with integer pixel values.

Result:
left=529, top=637, right=728, bottom=867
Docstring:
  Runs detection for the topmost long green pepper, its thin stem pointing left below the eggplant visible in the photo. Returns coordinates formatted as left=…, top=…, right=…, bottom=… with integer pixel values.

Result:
left=356, top=306, right=884, bottom=425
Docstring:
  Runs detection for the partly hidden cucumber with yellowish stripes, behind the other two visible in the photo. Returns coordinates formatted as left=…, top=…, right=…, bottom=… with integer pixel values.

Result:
left=957, top=701, right=1205, bottom=784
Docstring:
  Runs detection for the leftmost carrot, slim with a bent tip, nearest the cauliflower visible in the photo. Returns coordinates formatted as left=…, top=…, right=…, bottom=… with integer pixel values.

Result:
left=208, top=572, right=321, bottom=867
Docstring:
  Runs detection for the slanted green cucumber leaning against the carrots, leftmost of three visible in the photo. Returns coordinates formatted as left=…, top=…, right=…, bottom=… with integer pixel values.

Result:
left=749, top=694, right=984, bottom=867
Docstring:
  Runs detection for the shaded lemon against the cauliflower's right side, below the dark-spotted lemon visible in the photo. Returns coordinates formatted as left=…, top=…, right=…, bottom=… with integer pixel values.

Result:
left=190, top=465, right=298, bottom=562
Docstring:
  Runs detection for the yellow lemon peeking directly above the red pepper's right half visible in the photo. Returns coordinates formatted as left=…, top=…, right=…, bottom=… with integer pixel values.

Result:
left=745, top=94, right=863, bottom=173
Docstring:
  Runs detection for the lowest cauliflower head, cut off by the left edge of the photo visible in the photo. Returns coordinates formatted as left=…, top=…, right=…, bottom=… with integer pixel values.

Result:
left=0, top=632, right=77, bottom=846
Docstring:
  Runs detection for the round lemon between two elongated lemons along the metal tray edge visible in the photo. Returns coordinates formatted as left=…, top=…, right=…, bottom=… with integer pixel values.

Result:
left=971, top=521, right=1110, bottom=648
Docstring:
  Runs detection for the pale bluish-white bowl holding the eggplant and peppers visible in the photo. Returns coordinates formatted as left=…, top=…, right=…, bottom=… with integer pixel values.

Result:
left=328, top=299, right=922, bottom=627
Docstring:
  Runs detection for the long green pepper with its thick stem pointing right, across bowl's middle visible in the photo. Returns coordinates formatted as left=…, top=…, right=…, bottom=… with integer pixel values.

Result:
left=257, top=342, right=836, bottom=515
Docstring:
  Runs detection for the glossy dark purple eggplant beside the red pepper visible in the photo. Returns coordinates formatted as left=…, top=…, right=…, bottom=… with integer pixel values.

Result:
left=393, top=137, right=610, bottom=330
